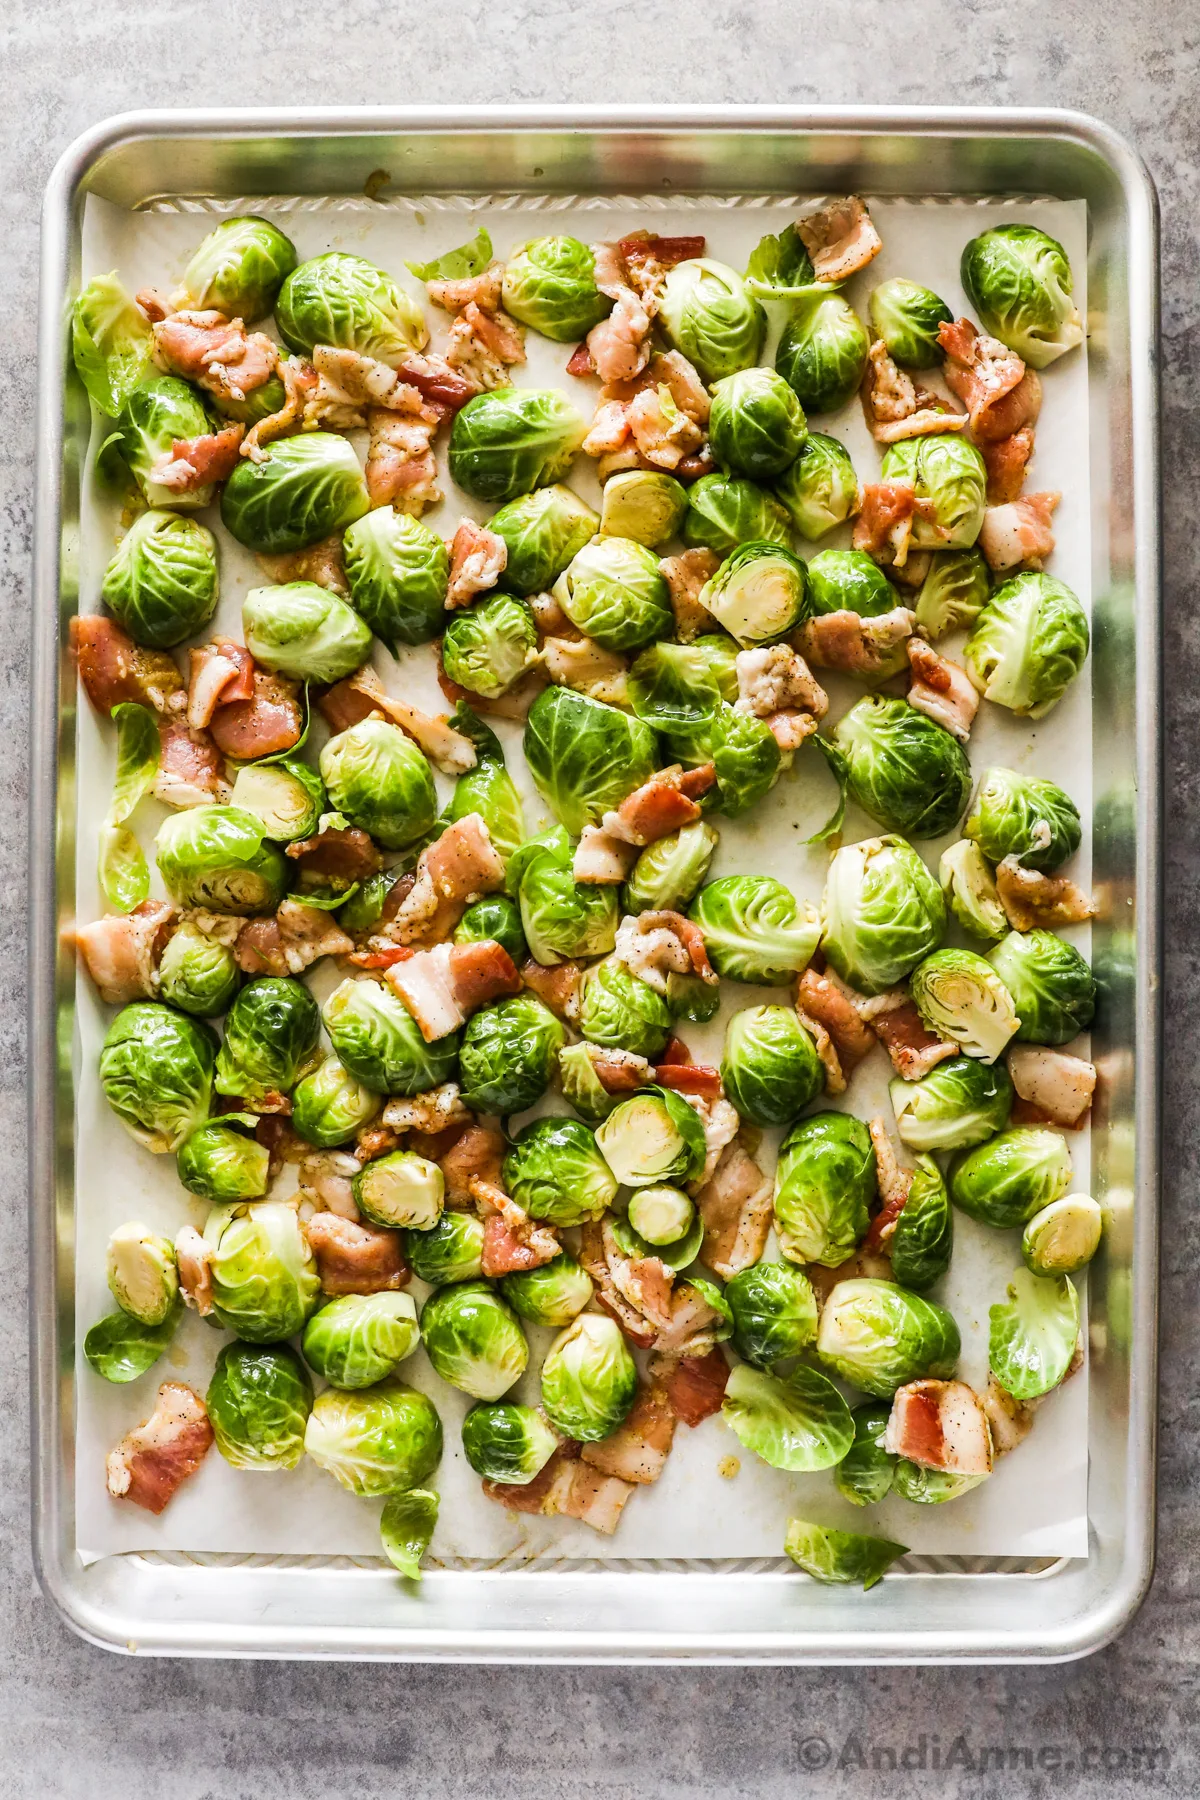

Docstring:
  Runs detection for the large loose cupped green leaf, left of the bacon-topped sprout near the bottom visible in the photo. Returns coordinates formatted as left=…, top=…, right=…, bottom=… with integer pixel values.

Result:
left=721, top=1363, right=855, bottom=1474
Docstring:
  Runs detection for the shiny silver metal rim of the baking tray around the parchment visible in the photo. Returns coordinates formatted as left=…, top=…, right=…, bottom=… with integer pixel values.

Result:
left=29, top=106, right=1160, bottom=1663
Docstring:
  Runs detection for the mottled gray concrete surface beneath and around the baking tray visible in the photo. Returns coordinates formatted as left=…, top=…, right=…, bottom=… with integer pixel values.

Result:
left=0, top=0, right=1200, bottom=1800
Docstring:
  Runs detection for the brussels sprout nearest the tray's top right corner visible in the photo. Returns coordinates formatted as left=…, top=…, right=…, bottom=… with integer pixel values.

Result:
left=959, top=225, right=1083, bottom=369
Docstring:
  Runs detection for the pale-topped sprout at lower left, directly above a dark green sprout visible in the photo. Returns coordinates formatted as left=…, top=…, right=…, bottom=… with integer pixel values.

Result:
left=203, top=1201, right=320, bottom=1345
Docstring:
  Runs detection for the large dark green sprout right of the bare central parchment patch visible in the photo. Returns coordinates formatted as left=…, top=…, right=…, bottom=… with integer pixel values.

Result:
left=833, top=693, right=972, bottom=837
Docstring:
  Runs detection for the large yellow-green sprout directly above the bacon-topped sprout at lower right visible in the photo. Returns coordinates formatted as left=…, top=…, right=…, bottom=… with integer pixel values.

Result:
left=817, top=1278, right=961, bottom=1400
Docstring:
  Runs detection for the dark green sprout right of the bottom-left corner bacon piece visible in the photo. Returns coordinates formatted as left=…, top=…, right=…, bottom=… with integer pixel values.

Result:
left=205, top=1345, right=313, bottom=1469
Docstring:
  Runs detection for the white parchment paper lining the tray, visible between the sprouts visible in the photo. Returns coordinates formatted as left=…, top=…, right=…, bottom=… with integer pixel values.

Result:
left=74, top=186, right=1092, bottom=1566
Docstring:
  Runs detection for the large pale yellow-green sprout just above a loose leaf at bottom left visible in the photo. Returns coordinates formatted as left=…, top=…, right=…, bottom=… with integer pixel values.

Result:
left=304, top=1379, right=443, bottom=1499
